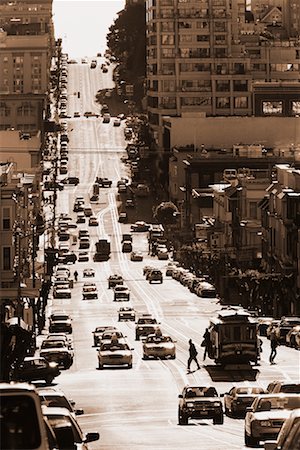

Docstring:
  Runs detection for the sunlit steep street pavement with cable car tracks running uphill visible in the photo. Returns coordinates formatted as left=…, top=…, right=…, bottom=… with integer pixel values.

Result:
left=40, top=58, right=299, bottom=450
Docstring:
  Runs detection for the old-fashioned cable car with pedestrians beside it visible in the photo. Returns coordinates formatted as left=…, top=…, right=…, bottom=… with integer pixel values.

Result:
left=206, top=307, right=260, bottom=365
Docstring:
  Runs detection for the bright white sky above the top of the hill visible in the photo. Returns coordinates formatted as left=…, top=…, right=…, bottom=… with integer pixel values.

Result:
left=53, top=0, right=125, bottom=58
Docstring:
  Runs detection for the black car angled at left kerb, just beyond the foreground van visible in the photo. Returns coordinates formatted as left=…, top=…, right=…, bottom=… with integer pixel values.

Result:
left=15, top=357, right=60, bottom=384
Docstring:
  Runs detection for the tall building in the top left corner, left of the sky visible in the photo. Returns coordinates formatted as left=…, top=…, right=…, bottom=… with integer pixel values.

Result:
left=0, top=0, right=55, bottom=134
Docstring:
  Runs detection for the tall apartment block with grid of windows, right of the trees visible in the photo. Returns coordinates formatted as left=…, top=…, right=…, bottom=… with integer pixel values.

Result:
left=146, top=0, right=300, bottom=147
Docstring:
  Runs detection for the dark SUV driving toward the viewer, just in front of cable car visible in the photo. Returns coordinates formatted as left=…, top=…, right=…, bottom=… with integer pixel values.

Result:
left=178, top=386, right=224, bottom=425
